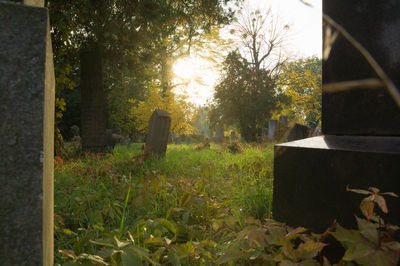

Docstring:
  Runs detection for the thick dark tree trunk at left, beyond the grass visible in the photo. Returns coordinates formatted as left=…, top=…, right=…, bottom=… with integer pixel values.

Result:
left=80, top=44, right=108, bottom=152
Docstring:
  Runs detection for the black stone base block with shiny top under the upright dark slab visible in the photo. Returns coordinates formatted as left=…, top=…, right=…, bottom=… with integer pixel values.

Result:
left=273, top=135, right=400, bottom=232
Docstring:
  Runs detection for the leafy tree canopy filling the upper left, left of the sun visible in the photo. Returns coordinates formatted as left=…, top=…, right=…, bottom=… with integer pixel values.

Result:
left=47, top=0, right=239, bottom=150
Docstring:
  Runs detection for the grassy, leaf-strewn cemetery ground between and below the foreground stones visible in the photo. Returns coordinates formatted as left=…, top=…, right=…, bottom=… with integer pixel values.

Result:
left=54, top=143, right=400, bottom=265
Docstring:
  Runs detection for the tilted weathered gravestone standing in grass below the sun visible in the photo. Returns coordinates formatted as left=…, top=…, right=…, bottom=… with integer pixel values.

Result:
left=146, top=109, right=171, bottom=158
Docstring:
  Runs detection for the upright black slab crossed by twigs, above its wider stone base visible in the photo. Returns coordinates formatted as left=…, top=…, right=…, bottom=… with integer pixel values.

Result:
left=322, top=0, right=400, bottom=136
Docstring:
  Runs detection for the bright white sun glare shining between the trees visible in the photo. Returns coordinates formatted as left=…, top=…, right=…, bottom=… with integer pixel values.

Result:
left=173, top=57, right=218, bottom=105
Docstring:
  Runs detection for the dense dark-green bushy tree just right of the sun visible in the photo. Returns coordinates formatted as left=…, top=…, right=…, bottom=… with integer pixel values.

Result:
left=210, top=51, right=276, bottom=142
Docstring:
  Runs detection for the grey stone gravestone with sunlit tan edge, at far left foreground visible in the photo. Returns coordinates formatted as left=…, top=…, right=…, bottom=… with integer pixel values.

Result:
left=0, top=1, right=54, bottom=265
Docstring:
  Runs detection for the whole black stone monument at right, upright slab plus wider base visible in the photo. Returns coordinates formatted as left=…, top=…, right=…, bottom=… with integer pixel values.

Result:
left=273, top=0, right=400, bottom=237
